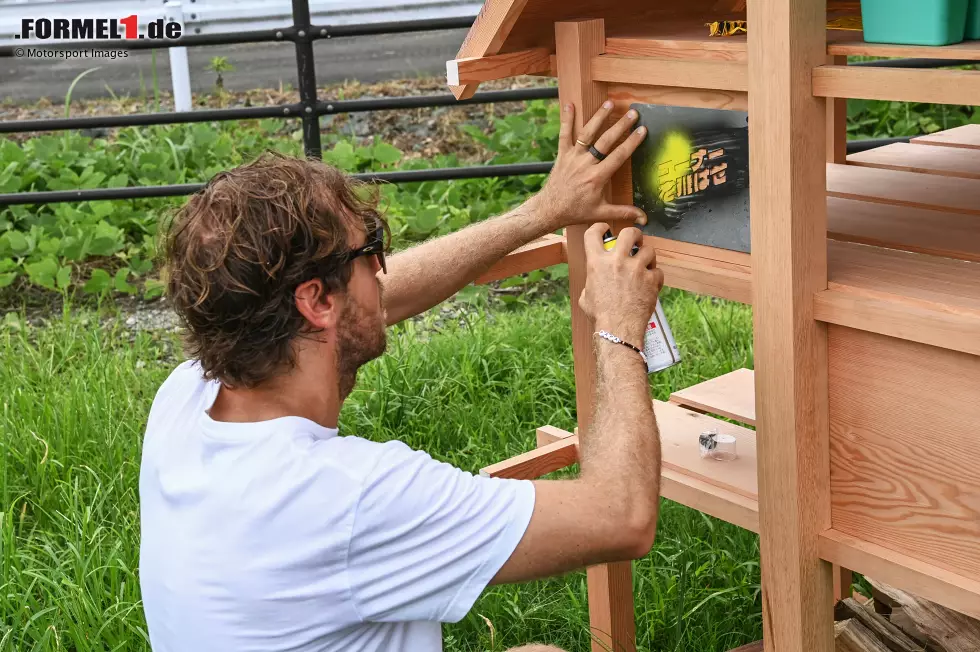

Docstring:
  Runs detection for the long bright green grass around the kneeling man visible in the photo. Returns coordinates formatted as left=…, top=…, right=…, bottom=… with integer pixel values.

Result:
left=0, top=291, right=761, bottom=652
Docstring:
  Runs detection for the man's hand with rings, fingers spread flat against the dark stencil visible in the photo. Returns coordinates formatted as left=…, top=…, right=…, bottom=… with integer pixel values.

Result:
left=534, top=101, right=647, bottom=231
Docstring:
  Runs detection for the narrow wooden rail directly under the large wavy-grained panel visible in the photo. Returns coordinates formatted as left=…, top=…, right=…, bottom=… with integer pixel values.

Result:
left=820, top=529, right=980, bottom=618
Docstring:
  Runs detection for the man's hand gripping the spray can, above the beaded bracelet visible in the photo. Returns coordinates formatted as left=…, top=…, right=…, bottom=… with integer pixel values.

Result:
left=579, top=222, right=664, bottom=350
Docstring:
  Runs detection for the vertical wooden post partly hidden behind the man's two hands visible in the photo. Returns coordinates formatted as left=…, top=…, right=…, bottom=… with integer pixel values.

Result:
left=555, top=20, right=636, bottom=652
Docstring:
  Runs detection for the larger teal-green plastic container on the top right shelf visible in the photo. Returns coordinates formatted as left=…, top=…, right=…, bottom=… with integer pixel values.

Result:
left=861, top=0, right=978, bottom=45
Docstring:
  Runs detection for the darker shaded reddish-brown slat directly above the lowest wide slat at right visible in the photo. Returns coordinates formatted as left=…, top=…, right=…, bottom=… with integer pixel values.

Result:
left=827, top=196, right=980, bottom=262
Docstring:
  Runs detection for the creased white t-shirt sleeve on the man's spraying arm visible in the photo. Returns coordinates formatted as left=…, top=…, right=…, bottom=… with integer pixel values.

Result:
left=348, top=442, right=534, bottom=622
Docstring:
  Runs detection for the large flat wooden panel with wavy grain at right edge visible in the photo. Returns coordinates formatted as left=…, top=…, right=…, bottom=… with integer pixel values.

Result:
left=828, top=326, right=980, bottom=580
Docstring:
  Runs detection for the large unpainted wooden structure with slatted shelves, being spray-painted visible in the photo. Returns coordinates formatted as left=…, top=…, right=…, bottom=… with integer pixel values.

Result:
left=448, top=0, right=980, bottom=652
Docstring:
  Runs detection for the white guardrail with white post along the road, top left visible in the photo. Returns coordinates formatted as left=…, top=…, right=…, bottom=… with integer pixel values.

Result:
left=0, top=0, right=483, bottom=111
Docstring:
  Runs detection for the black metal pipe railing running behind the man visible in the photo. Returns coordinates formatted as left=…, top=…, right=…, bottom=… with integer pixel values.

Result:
left=0, top=0, right=976, bottom=206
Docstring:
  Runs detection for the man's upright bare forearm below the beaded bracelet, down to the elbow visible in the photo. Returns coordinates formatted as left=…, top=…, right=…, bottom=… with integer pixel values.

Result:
left=580, top=333, right=660, bottom=522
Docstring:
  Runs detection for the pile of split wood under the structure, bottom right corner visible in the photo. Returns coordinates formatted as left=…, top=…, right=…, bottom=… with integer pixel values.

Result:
left=834, top=578, right=980, bottom=652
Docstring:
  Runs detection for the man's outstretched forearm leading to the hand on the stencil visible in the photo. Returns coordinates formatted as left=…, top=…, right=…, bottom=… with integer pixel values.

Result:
left=380, top=197, right=550, bottom=325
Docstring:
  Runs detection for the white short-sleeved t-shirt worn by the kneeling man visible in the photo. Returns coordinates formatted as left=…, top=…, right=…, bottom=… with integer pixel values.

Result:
left=140, top=362, right=534, bottom=652
